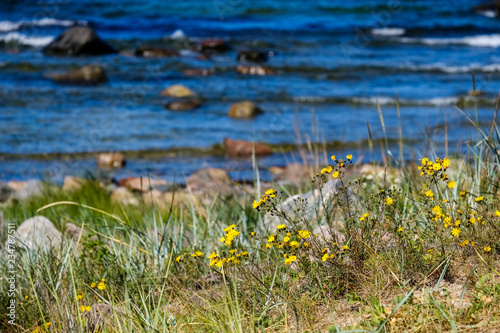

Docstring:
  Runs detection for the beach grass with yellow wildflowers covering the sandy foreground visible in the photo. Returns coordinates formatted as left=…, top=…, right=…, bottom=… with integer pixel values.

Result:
left=0, top=114, right=500, bottom=332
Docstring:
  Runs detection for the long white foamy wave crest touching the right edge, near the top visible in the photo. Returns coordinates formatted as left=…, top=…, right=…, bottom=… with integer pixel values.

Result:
left=399, top=34, right=500, bottom=48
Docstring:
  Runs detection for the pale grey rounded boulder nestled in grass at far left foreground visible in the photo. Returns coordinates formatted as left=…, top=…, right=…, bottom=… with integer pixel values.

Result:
left=14, top=216, right=62, bottom=250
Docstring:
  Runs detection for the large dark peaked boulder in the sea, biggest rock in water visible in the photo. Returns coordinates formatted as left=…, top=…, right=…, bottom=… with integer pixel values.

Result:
left=43, top=25, right=116, bottom=56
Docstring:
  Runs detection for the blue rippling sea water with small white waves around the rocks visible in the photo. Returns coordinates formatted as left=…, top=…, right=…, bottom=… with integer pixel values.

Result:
left=0, top=0, right=500, bottom=180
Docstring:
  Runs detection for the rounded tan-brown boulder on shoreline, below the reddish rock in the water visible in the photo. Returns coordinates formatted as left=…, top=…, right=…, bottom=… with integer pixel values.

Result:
left=186, top=168, right=235, bottom=198
